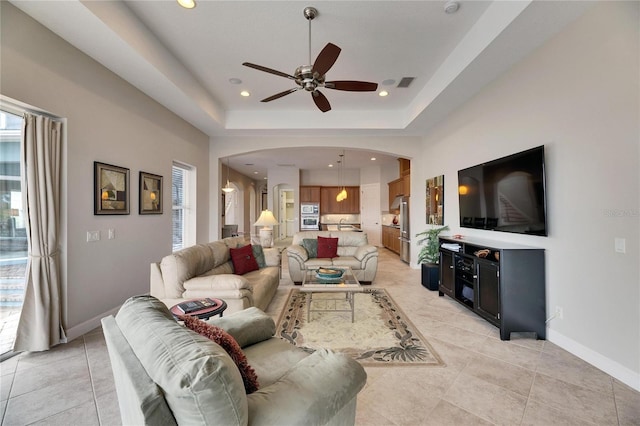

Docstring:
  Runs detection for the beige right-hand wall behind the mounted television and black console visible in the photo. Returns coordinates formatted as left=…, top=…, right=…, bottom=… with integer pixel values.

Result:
left=412, top=2, right=640, bottom=389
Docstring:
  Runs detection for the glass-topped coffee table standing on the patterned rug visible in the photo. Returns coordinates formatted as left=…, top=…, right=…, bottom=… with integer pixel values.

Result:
left=300, top=266, right=364, bottom=322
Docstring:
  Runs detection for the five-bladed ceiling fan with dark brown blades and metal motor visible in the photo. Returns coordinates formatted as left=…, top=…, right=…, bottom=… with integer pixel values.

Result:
left=242, top=7, right=378, bottom=112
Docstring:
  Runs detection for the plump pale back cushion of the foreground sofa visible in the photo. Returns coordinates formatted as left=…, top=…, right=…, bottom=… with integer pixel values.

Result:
left=116, top=295, right=248, bottom=424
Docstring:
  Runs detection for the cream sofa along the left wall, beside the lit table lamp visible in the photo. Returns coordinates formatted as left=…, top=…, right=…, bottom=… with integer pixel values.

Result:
left=149, top=237, right=280, bottom=313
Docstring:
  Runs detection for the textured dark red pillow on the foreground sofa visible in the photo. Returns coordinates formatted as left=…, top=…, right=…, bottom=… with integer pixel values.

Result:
left=179, top=315, right=259, bottom=394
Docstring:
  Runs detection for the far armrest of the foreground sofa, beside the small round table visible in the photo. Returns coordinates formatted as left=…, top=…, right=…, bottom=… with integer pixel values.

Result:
left=206, top=307, right=276, bottom=348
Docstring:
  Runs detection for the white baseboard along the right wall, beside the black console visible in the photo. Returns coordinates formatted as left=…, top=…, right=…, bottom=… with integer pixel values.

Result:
left=547, top=329, right=640, bottom=392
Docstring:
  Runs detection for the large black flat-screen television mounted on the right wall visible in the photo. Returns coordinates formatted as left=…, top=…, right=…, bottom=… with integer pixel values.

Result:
left=458, top=146, right=547, bottom=236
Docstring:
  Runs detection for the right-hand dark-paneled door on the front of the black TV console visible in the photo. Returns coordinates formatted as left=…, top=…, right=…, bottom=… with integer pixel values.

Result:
left=475, top=260, right=500, bottom=325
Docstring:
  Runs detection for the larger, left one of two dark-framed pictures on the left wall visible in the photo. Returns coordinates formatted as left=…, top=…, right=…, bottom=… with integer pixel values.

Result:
left=93, top=161, right=129, bottom=215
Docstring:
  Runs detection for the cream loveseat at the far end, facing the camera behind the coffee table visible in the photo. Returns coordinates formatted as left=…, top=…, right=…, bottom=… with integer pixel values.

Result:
left=286, top=231, right=378, bottom=284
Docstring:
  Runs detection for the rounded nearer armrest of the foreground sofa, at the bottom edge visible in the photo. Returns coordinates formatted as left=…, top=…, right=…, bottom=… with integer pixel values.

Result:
left=247, top=350, right=367, bottom=426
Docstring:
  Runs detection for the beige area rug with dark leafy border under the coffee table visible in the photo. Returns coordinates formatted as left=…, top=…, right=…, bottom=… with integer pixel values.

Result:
left=276, top=288, right=445, bottom=366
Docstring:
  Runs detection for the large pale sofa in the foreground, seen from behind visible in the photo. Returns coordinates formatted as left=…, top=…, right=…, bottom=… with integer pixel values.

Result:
left=102, top=296, right=367, bottom=426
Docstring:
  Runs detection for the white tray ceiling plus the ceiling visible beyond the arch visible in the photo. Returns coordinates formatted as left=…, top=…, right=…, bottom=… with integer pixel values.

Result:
left=11, top=0, right=590, bottom=175
